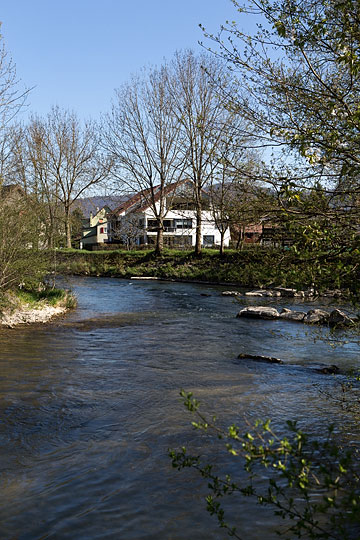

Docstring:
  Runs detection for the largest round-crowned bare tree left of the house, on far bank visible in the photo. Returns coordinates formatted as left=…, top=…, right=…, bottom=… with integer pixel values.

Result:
left=29, top=107, right=111, bottom=247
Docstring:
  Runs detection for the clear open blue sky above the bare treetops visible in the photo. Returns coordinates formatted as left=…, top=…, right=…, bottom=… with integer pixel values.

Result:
left=0, top=0, right=235, bottom=118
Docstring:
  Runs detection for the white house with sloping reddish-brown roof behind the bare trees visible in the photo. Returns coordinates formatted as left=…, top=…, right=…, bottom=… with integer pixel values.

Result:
left=108, top=182, right=230, bottom=248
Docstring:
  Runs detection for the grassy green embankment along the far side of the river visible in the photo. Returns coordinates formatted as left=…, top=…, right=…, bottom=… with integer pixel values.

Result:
left=57, top=246, right=358, bottom=292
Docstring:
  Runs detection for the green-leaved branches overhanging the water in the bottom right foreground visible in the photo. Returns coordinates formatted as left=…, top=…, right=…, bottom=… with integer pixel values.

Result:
left=169, top=390, right=360, bottom=540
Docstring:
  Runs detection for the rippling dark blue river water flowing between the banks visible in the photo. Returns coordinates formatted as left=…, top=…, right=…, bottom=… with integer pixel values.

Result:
left=0, top=278, right=360, bottom=540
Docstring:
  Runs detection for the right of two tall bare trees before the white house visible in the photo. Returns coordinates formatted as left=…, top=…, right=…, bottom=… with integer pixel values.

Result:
left=172, top=51, right=239, bottom=254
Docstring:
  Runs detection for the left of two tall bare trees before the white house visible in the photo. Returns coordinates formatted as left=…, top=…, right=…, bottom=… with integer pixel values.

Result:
left=103, top=65, right=185, bottom=253
